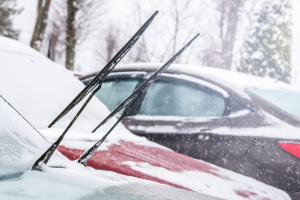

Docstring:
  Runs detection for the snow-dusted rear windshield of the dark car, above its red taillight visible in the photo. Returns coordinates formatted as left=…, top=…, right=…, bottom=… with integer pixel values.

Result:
left=247, top=88, right=300, bottom=117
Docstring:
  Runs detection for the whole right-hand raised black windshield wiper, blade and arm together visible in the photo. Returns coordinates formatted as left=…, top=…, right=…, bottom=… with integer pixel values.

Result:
left=78, top=33, right=199, bottom=166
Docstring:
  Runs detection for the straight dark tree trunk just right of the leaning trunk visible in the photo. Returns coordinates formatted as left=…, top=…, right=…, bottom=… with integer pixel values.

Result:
left=66, top=0, right=78, bottom=70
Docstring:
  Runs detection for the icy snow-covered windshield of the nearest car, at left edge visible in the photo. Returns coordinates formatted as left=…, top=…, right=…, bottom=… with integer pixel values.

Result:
left=0, top=96, right=49, bottom=180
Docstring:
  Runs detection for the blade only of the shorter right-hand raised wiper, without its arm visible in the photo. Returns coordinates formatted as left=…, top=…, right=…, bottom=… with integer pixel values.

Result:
left=92, top=33, right=199, bottom=133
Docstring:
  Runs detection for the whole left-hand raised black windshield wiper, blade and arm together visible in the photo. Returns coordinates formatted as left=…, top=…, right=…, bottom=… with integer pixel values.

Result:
left=32, top=11, right=158, bottom=170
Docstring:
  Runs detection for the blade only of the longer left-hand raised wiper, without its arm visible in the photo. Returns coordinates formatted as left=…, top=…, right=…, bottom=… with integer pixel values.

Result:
left=48, top=11, right=158, bottom=128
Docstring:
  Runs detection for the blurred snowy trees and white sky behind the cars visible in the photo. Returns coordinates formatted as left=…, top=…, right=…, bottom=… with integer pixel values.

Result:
left=0, top=0, right=300, bottom=86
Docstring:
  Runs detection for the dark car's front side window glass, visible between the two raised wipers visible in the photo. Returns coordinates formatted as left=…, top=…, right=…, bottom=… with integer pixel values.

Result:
left=95, top=79, right=138, bottom=111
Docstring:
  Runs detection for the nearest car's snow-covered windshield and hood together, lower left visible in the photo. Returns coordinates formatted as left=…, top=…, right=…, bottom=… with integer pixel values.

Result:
left=0, top=97, right=223, bottom=200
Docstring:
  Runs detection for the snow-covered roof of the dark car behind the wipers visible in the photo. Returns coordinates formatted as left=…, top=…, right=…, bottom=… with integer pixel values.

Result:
left=81, top=63, right=300, bottom=99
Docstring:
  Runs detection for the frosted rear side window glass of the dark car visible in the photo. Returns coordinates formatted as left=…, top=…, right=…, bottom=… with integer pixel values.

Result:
left=139, top=81, right=225, bottom=117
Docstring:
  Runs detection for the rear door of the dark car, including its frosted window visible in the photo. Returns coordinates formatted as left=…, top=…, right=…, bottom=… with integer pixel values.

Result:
left=123, top=73, right=230, bottom=153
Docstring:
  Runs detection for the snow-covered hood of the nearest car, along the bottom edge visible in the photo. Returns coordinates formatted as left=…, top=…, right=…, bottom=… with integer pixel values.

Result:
left=0, top=168, right=219, bottom=200
